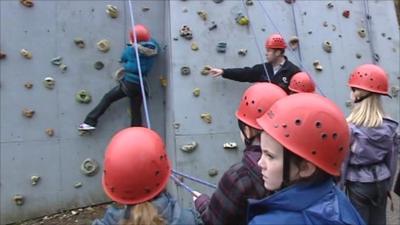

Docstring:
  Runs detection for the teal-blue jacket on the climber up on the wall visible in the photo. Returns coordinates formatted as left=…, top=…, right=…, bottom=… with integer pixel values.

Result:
left=121, top=39, right=160, bottom=84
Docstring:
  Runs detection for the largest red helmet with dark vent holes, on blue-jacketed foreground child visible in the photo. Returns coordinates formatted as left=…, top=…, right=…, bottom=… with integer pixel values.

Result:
left=257, top=93, right=349, bottom=176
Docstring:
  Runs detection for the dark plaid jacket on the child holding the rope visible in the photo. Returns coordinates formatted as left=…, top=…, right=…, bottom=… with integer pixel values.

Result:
left=195, top=146, right=267, bottom=225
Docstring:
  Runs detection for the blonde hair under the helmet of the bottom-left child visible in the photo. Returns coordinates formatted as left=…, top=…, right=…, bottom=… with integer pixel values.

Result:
left=120, top=202, right=166, bottom=225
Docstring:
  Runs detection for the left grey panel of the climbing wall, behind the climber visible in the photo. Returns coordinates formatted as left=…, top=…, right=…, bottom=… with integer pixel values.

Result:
left=0, top=1, right=166, bottom=224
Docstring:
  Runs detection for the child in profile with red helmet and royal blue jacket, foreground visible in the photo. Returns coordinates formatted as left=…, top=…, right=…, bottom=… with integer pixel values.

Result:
left=248, top=93, right=364, bottom=225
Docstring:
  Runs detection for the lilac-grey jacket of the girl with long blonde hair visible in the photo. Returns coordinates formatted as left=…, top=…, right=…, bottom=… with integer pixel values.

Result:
left=342, top=118, right=400, bottom=189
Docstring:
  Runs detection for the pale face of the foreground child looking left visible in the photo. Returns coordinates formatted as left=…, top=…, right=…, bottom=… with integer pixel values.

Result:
left=258, top=132, right=283, bottom=191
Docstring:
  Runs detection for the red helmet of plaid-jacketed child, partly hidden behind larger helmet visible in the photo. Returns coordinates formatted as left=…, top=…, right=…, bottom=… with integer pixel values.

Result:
left=236, top=82, right=287, bottom=130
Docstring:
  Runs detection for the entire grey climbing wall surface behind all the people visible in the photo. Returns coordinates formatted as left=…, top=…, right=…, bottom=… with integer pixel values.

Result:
left=0, top=0, right=400, bottom=224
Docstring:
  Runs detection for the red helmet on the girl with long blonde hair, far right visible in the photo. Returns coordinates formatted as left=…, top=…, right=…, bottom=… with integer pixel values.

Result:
left=348, top=64, right=389, bottom=95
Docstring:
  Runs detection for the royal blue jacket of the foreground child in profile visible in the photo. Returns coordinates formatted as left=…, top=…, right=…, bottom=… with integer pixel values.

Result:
left=248, top=179, right=365, bottom=225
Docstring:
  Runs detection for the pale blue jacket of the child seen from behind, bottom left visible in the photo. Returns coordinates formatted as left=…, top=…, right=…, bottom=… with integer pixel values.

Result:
left=92, top=192, right=199, bottom=225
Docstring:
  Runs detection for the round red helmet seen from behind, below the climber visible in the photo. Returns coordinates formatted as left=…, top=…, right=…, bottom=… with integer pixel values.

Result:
left=103, top=127, right=171, bottom=205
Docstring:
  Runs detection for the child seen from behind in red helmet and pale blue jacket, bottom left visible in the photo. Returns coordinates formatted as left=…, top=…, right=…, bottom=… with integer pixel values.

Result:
left=92, top=127, right=200, bottom=225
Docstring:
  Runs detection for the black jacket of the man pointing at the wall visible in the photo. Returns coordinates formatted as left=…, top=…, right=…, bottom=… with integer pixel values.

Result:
left=222, top=56, right=300, bottom=93
